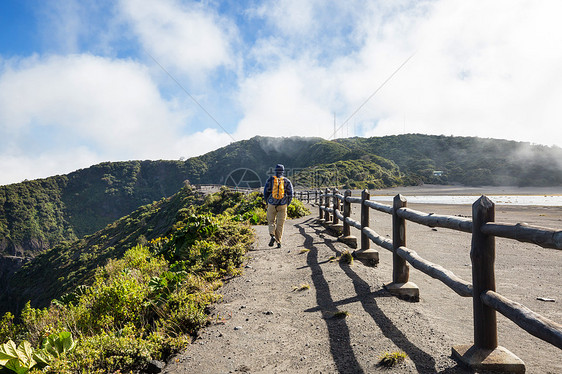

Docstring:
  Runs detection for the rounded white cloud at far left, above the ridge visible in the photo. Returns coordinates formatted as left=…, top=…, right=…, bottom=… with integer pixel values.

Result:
left=0, top=55, right=185, bottom=156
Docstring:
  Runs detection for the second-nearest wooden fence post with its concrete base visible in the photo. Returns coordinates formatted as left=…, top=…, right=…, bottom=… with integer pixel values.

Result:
left=385, top=194, right=420, bottom=301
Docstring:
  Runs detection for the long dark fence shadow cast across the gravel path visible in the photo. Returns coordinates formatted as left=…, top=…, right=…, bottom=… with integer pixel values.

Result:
left=295, top=219, right=469, bottom=373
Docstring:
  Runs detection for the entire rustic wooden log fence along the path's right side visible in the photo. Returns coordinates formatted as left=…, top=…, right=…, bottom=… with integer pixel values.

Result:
left=290, top=189, right=562, bottom=373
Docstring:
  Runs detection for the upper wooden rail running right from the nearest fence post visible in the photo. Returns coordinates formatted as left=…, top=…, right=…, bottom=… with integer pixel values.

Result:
left=481, top=222, right=562, bottom=249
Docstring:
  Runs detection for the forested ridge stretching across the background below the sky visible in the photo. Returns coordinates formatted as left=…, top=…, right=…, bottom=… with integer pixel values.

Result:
left=0, top=134, right=562, bottom=268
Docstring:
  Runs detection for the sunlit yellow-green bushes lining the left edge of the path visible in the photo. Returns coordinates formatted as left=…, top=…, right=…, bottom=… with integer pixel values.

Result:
left=0, top=210, right=253, bottom=373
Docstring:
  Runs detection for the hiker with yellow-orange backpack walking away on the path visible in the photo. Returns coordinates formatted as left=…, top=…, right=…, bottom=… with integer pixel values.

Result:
left=263, top=164, right=293, bottom=248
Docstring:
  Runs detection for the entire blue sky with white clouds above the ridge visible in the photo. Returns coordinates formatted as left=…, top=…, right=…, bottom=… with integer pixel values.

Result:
left=0, top=0, right=562, bottom=184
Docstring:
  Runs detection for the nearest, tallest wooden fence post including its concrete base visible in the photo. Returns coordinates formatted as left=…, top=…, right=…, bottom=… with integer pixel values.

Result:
left=453, top=196, right=525, bottom=373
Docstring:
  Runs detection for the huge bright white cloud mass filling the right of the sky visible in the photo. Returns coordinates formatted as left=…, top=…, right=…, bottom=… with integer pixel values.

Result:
left=240, top=1, right=562, bottom=145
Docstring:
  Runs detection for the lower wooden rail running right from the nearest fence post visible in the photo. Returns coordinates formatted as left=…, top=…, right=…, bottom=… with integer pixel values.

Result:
left=480, top=291, right=562, bottom=349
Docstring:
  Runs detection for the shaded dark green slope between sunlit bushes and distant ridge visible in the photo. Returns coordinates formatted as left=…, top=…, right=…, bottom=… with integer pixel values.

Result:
left=0, top=187, right=203, bottom=311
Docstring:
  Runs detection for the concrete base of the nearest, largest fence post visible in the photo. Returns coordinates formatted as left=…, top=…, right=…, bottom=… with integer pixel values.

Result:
left=452, top=345, right=525, bottom=374
